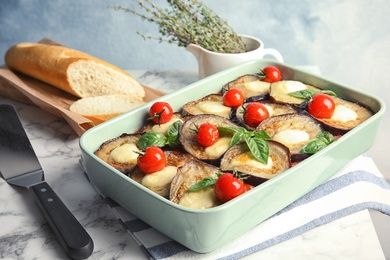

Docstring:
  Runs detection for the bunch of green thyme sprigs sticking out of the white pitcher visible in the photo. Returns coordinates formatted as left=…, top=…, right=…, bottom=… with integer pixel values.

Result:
left=112, top=0, right=245, bottom=53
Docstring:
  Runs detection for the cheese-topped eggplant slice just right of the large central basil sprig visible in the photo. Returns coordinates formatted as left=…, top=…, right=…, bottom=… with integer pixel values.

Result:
left=256, top=114, right=323, bottom=156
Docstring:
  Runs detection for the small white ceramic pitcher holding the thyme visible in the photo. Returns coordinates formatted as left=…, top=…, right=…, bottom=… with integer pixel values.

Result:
left=186, top=35, right=283, bottom=79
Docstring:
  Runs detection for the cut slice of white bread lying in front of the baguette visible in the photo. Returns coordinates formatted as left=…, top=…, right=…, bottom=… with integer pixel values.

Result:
left=69, top=95, right=145, bottom=125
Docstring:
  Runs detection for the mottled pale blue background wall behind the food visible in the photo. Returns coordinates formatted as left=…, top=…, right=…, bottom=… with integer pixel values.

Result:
left=0, top=0, right=390, bottom=175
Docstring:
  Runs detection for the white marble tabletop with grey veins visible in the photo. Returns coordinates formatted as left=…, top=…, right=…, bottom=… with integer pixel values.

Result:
left=0, top=71, right=385, bottom=259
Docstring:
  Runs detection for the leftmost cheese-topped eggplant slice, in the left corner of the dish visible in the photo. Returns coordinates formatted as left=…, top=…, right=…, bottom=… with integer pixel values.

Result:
left=95, top=134, right=141, bottom=173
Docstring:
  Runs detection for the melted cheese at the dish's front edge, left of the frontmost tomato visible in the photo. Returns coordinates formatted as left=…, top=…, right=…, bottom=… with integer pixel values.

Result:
left=179, top=186, right=217, bottom=209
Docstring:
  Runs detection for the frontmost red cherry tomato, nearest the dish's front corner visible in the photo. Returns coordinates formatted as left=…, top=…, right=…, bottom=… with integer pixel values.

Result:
left=214, top=173, right=245, bottom=202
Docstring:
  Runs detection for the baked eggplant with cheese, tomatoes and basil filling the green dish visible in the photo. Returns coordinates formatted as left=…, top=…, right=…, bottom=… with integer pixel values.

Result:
left=95, top=67, right=373, bottom=209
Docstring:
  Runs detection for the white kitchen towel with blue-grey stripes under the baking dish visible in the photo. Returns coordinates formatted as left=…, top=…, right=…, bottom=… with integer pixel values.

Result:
left=83, top=155, right=390, bottom=259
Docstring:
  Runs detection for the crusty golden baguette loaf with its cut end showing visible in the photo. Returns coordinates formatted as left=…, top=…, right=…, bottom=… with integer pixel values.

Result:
left=5, top=43, right=145, bottom=99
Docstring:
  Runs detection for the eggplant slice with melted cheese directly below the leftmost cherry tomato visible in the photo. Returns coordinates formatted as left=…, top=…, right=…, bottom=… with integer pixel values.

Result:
left=128, top=151, right=195, bottom=198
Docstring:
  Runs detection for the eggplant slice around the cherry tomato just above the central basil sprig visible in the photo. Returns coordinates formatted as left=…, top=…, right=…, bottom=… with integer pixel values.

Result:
left=232, top=101, right=297, bottom=130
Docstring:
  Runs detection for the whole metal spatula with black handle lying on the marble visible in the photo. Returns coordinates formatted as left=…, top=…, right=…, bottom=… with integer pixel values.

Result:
left=0, top=104, right=93, bottom=259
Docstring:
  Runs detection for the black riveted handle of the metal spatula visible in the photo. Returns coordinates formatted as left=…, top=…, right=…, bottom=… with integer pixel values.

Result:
left=29, top=182, right=93, bottom=259
